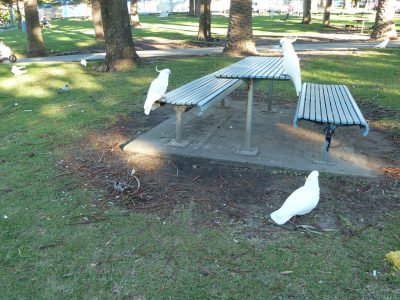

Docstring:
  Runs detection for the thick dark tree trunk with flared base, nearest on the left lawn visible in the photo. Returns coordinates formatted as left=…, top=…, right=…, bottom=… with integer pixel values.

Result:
left=99, top=0, right=139, bottom=72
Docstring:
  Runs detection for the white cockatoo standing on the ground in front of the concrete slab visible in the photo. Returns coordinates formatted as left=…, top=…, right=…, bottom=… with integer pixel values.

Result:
left=271, top=171, right=319, bottom=225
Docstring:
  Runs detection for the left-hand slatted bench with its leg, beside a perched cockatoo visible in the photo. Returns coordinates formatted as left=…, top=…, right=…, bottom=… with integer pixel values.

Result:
left=160, top=73, right=242, bottom=147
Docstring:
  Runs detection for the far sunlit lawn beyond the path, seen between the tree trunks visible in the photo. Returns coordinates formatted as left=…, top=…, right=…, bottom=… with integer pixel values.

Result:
left=0, top=14, right=400, bottom=56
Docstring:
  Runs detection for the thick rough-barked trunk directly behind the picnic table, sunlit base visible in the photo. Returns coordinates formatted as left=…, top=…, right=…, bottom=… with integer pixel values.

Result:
left=223, top=0, right=257, bottom=55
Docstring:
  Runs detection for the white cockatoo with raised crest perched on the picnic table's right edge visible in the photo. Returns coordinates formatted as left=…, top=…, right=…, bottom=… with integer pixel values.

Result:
left=279, top=38, right=301, bottom=96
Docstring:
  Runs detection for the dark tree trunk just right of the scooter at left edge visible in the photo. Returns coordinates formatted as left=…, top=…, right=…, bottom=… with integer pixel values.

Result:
left=24, top=0, right=46, bottom=57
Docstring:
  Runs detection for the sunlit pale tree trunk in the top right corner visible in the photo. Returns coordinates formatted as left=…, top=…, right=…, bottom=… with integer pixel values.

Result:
left=371, top=0, right=397, bottom=40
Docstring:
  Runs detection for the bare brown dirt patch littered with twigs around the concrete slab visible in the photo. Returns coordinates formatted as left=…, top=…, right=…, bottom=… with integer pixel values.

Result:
left=59, top=88, right=400, bottom=238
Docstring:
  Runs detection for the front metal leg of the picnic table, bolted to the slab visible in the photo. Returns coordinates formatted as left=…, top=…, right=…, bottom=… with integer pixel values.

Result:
left=236, top=79, right=258, bottom=156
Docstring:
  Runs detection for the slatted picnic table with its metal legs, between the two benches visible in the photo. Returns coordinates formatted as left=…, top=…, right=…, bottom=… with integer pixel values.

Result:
left=215, top=56, right=290, bottom=155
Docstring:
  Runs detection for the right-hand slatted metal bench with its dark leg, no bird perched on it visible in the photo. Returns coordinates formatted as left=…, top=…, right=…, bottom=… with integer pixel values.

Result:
left=293, top=83, right=369, bottom=164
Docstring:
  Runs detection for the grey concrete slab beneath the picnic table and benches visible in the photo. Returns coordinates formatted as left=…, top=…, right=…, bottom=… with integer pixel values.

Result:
left=124, top=99, right=377, bottom=176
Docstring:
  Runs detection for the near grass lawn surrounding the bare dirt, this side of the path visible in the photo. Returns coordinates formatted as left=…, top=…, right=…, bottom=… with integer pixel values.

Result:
left=0, top=49, right=400, bottom=299
